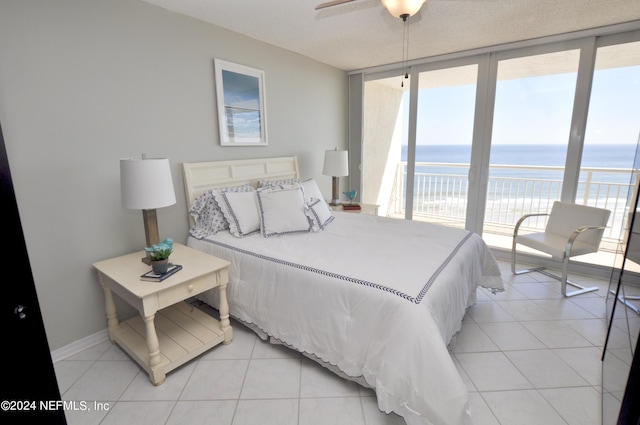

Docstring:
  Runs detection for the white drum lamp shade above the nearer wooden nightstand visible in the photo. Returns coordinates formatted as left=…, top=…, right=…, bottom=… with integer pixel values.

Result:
left=120, top=158, right=176, bottom=210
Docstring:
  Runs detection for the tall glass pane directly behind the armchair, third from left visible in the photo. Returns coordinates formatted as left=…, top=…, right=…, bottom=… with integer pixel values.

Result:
left=483, top=49, right=580, bottom=247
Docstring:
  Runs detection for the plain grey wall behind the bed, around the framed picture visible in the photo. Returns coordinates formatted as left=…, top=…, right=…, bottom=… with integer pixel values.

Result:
left=0, top=0, right=347, bottom=350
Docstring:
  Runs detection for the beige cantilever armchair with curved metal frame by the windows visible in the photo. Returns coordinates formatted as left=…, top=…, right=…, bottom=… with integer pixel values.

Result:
left=511, top=201, right=611, bottom=297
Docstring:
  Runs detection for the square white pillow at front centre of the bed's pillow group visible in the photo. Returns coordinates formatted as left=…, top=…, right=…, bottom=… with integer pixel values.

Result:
left=256, top=187, right=311, bottom=238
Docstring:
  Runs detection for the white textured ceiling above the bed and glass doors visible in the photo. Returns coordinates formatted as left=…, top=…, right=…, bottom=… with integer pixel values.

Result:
left=142, top=0, right=640, bottom=71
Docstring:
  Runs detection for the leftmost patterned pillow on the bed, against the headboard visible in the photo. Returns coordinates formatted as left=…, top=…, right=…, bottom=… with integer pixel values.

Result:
left=189, top=184, right=254, bottom=239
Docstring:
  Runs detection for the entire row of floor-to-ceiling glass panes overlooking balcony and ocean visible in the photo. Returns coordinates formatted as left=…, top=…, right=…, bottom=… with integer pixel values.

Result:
left=358, top=26, right=640, bottom=270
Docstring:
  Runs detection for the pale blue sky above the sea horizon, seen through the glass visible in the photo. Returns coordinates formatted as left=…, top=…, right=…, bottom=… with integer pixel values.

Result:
left=405, top=66, right=640, bottom=144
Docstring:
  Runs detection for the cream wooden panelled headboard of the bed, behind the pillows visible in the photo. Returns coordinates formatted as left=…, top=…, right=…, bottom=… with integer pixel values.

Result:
left=182, top=156, right=299, bottom=211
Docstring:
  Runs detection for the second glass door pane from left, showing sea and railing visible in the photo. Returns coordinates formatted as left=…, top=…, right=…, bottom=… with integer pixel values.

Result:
left=402, top=64, right=478, bottom=228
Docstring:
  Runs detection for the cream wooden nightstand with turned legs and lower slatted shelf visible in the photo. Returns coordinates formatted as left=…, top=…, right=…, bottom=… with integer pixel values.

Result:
left=93, top=243, right=233, bottom=385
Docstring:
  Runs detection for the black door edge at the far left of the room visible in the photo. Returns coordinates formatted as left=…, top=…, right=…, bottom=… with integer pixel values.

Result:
left=0, top=120, right=66, bottom=424
